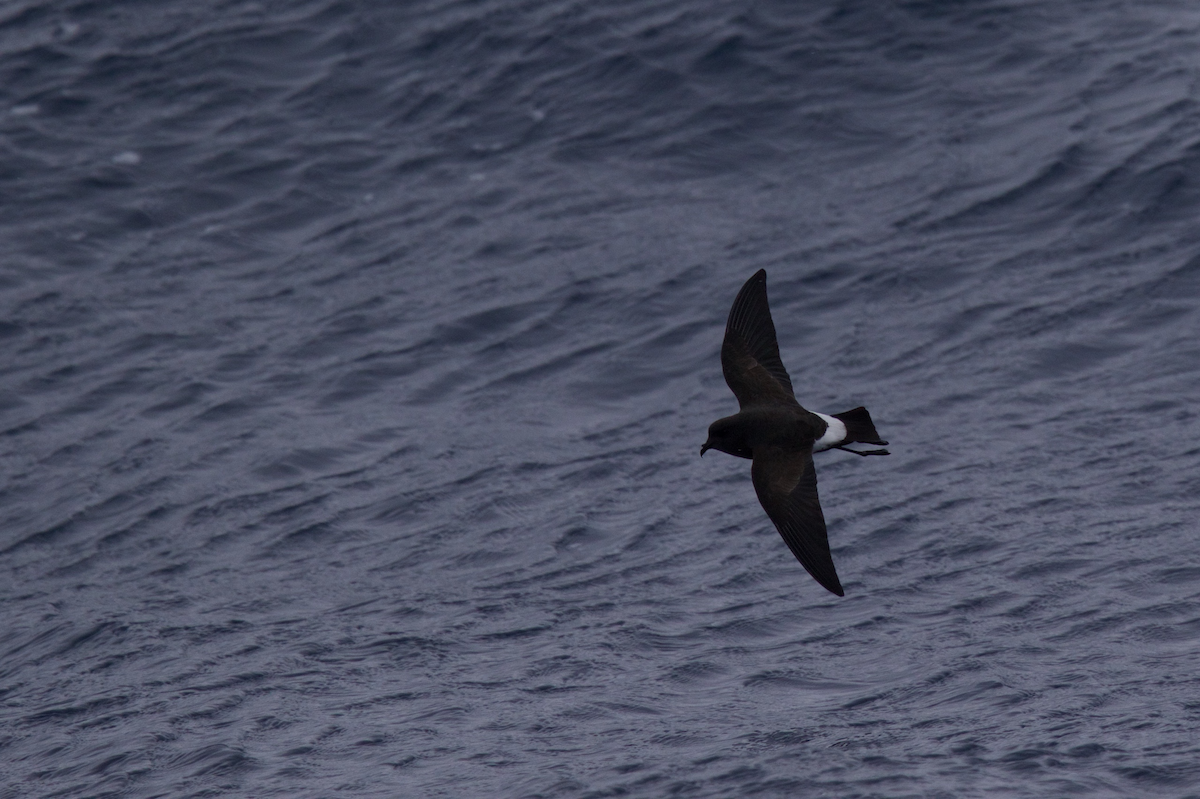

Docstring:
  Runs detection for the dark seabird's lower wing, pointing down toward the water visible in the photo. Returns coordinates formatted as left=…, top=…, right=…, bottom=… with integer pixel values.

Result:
left=750, top=446, right=845, bottom=596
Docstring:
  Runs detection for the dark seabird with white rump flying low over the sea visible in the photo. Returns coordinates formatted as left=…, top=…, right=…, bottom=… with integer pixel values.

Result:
left=700, top=269, right=889, bottom=596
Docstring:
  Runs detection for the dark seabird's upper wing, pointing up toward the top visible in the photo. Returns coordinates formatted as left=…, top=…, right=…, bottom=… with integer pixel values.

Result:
left=721, top=269, right=797, bottom=408
